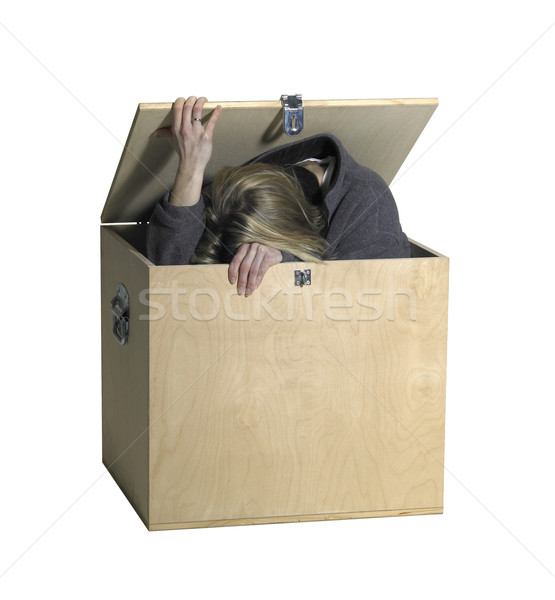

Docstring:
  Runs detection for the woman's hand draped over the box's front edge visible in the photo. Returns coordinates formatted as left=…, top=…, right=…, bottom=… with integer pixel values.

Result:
left=228, top=242, right=282, bottom=297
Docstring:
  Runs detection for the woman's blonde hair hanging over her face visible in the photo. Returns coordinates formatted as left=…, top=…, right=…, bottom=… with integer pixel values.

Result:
left=192, top=163, right=328, bottom=263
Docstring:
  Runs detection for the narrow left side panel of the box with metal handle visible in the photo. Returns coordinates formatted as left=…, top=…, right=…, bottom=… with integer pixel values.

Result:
left=101, top=227, right=149, bottom=523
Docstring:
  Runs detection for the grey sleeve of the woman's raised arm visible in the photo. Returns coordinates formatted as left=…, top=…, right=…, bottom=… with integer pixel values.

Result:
left=146, top=192, right=205, bottom=265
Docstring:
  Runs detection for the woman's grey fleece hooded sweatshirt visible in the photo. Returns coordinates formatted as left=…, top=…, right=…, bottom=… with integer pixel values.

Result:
left=147, top=134, right=410, bottom=265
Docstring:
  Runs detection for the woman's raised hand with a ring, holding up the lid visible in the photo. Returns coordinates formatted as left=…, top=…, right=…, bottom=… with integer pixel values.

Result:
left=153, top=96, right=222, bottom=206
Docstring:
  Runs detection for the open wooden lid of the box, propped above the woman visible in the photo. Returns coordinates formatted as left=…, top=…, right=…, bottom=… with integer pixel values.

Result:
left=100, top=98, right=437, bottom=223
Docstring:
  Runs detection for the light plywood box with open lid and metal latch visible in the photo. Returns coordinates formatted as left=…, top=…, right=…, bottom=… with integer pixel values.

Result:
left=101, top=100, right=448, bottom=530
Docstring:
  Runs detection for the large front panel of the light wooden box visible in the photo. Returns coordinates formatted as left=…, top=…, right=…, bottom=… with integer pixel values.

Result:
left=150, top=257, right=448, bottom=528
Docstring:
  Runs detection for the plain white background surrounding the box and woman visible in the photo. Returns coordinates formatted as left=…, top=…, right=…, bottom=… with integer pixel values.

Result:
left=0, top=0, right=555, bottom=599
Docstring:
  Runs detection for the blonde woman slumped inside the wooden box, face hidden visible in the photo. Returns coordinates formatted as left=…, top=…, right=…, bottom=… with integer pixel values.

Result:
left=147, top=96, right=410, bottom=296
